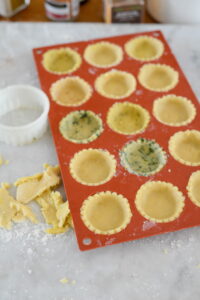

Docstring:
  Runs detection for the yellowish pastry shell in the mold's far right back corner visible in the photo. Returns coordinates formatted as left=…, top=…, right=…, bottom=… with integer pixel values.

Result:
left=125, top=35, right=164, bottom=62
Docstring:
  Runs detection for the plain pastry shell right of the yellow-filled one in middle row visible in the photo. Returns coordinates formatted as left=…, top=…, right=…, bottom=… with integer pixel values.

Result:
left=153, top=95, right=196, bottom=127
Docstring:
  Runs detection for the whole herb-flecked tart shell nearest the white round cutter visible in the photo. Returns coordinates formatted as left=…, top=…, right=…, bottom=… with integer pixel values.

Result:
left=59, top=110, right=103, bottom=144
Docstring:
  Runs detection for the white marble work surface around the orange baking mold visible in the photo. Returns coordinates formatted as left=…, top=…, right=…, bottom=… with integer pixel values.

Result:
left=0, top=23, right=200, bottom=300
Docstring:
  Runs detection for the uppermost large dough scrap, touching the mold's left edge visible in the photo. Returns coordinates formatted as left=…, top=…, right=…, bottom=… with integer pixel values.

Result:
left=15, top=165, right=60, bottom=203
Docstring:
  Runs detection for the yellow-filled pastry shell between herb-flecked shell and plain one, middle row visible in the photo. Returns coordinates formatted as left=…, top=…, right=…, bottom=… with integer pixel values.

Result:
left=107, top=102, right=150, bottom=135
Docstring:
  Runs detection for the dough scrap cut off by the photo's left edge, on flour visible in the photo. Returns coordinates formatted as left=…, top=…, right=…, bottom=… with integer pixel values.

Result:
left=0, top=188, right=38, bottom=229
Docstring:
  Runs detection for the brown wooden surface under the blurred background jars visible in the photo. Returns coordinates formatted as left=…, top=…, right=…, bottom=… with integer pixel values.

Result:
left=0, top=0, right=156, bottom=23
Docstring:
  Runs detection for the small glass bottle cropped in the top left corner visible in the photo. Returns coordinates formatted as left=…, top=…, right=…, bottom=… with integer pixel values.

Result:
left=0, top=0, right=30, bottom=18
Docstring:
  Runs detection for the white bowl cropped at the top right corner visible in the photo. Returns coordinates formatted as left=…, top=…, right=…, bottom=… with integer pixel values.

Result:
left=147, top=0, right=200, bottom=24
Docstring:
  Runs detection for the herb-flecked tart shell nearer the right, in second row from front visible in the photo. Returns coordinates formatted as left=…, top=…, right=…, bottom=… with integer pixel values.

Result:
left=120, top=138, right=167, bottom=176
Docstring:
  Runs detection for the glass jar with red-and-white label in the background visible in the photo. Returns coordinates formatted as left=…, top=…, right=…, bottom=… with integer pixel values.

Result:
left=45, top=0, right=80, bottom=21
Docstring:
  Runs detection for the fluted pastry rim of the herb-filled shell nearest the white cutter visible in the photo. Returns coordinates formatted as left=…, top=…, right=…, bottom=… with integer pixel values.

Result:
left=59, top=110, right=103, bottom=144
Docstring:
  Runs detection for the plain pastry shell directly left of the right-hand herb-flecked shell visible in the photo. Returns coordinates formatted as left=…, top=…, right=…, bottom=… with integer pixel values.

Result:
left=69, top=148, right=117, bottom=186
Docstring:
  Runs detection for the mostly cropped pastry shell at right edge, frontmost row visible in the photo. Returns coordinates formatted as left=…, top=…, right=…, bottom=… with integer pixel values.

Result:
left=187, top=170, right=200, bottom=207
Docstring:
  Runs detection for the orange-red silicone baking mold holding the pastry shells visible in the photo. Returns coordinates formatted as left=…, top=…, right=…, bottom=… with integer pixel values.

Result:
left=33, top=31, right=200, bottom=250
